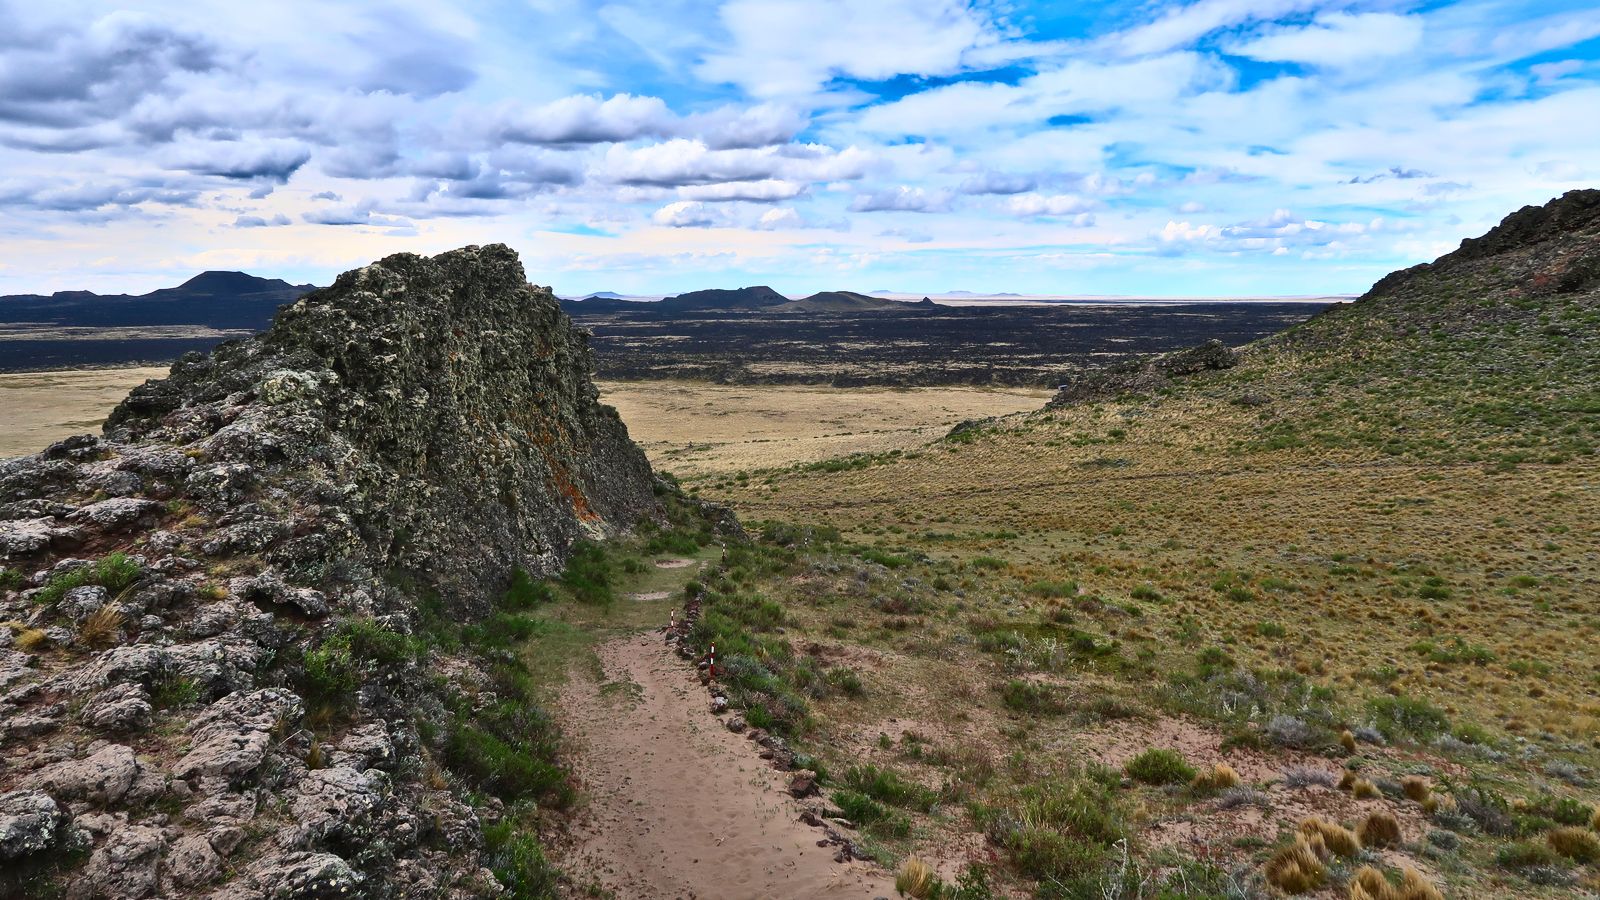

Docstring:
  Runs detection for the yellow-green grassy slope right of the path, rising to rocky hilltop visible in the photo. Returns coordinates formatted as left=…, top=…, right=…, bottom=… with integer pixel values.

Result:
left=691, top=192, right=1600, bottom=897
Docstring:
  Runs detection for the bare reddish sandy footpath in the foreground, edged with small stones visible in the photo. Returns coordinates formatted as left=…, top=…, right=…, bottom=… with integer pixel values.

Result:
left=562, top=633, right=894, bottom=900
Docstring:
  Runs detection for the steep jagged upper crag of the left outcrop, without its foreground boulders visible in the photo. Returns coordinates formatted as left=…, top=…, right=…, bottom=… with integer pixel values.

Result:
left=106, top=245, right=659, bottom=612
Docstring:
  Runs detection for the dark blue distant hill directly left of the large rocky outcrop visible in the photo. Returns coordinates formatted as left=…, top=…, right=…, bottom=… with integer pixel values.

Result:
left=0, top=272, right=315, bottom=331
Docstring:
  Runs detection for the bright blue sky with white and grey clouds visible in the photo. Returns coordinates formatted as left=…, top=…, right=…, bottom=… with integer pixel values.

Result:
left=0, top=0, right=1600, bottom=296
